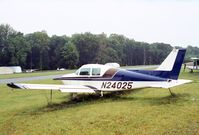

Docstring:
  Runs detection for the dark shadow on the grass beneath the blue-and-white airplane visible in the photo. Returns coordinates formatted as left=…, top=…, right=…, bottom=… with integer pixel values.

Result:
left=33, top=89, right=189, bottom=114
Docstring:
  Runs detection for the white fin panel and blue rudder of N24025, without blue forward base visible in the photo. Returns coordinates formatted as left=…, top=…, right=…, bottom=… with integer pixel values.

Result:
left=156, top=49, right=186, bottom=79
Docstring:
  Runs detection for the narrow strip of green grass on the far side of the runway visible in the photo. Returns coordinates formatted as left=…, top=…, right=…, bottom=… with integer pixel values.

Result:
left=0, top=70, right=74, bottom=79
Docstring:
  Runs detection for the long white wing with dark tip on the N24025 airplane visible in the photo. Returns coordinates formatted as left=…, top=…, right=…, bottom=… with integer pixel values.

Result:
left=7, top=83, right=96, bottom=93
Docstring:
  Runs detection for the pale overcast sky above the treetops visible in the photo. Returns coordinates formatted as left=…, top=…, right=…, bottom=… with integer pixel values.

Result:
left=0, top=0, right=199, bottom=47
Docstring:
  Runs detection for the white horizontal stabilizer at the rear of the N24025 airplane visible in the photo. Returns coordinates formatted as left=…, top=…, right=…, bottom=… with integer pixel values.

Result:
left=150, top=79, right=191, bottom=89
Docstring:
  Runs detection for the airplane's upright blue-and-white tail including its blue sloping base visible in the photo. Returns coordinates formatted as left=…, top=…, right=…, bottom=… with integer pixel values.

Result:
left=133, top=49, right=186, bottom=80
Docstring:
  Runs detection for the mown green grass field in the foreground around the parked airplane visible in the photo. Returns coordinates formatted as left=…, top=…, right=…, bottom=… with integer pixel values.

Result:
left=0, top=69, right=199, bottom=135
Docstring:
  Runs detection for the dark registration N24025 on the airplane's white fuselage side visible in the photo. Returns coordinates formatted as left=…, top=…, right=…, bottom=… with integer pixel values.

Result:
left=101, top=82, right=133, bottom=89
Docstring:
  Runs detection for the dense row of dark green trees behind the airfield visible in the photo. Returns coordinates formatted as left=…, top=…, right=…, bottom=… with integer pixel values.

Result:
left=0, top=24, right=199, bottom=70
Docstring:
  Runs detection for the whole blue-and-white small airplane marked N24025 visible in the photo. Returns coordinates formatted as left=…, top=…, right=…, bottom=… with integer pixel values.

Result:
left=7, top=49, right=191, bottom=96
